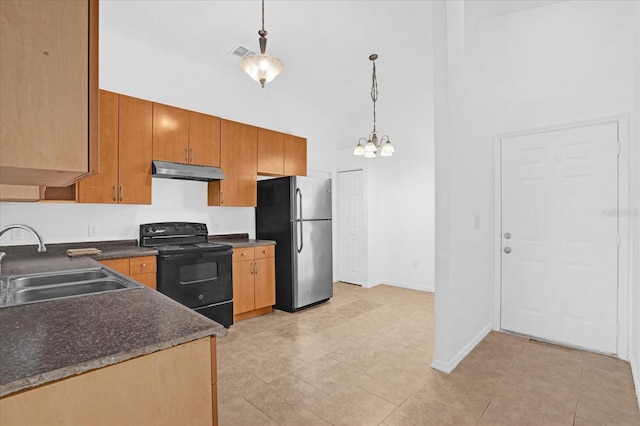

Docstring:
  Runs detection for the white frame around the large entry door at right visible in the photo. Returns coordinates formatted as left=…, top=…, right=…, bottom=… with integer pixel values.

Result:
left=491, top=114, right=632, bottom=360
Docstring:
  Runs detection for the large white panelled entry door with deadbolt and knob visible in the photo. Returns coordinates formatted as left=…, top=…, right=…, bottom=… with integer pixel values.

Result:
left=501, top=123, right=618, bottom=353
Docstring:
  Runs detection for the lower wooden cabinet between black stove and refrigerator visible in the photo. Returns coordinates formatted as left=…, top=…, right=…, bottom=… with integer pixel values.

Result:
left=233, top=245, right=276, bottom=322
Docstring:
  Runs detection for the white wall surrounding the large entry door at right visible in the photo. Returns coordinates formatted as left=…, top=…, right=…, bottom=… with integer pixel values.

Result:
left=434, top=1, right=640, bottom=371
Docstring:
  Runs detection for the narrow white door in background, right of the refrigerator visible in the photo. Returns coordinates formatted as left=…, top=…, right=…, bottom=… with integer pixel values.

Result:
left=338, top=170, right=363, bottom=285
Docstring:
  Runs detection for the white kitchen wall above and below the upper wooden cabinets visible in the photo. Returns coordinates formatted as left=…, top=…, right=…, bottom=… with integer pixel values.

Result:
left=0, top=29, right=336, bottom=245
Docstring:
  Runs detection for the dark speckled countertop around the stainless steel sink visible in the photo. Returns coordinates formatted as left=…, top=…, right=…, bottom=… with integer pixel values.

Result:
left=0, top=253, right=227, bottom=396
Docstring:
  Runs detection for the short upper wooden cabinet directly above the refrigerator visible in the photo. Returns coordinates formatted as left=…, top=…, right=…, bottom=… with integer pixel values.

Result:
left=258, top=128, right=307, bottom=176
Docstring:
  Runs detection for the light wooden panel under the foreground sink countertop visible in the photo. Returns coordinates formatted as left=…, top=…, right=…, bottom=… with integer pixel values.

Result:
left=0, top=337, right=218, bottom=426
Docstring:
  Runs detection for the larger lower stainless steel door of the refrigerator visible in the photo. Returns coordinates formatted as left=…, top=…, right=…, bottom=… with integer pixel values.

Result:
left=292, top=220, right=333, bottom=310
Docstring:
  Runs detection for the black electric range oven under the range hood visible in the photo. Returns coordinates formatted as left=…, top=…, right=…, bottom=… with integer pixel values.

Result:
left=140, top=222, right=233, bottom=328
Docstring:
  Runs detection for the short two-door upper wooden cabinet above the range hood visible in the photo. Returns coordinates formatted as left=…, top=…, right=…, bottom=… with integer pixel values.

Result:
left=153, top=103, right=220, bottom=166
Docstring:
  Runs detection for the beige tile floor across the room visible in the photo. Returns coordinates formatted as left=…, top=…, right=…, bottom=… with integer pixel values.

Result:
left=218, top=283, right=640, bottom=426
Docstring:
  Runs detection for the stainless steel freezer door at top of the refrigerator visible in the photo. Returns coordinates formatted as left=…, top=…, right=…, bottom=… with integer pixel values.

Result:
left=291, top=176, right=331, bottom=220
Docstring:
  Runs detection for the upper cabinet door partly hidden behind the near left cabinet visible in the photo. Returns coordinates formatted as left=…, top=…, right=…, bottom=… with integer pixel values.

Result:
left=78, top=90, right=119, bottom=204
